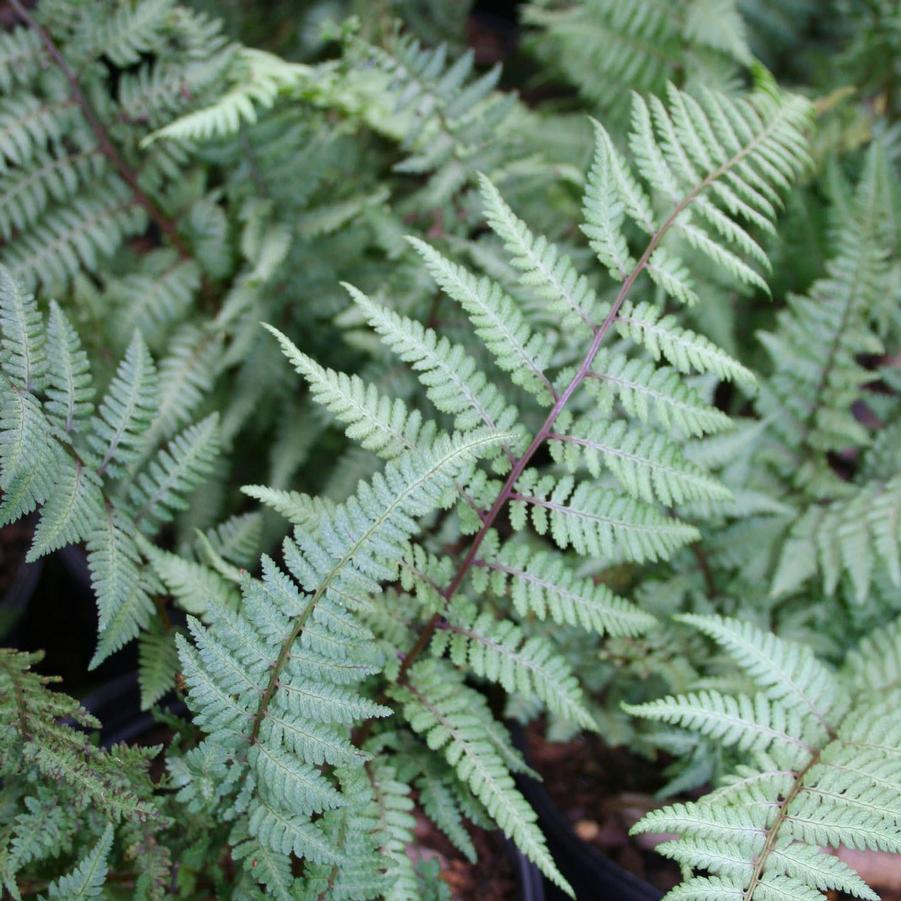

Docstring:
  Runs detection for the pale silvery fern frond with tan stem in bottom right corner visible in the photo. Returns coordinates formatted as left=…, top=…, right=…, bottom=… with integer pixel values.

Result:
left=628, top=616, right=901, bottom=899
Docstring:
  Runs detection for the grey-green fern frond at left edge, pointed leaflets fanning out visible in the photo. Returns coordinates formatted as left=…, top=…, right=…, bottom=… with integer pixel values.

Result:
left=0, top=269, right=217, bottom=676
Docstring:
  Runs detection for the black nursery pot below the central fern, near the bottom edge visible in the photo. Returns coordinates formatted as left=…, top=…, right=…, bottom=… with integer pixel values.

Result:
left=512, top=727, right=663, bottom=901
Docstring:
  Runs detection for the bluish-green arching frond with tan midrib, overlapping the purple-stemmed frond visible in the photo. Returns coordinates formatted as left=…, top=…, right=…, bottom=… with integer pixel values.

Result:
left=177, top=434, right=506, bottom=888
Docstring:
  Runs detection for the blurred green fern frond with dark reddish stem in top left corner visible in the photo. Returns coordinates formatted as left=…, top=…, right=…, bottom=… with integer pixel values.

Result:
left=0, top=0, right=231, bottom=287
